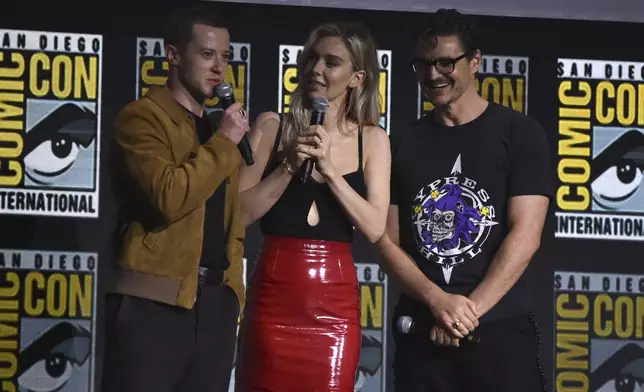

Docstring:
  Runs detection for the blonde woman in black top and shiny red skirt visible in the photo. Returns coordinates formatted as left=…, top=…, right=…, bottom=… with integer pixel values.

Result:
left=238, top=24, right=390, bottom=392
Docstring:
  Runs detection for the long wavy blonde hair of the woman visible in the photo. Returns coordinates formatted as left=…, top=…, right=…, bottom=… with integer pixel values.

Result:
left=282, top=23, right=380, bottom=146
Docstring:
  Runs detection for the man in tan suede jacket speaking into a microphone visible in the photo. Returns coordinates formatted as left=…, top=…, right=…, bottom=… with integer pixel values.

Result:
left=102, top=9, right=248, bottom=392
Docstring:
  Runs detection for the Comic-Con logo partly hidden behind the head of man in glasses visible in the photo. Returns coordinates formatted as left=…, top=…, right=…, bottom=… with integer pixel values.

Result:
left=418, top=55, right=530, bottom=117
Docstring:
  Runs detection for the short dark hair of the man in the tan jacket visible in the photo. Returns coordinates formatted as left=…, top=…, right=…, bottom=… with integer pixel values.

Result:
left=163, top=7, right=228, bottom=51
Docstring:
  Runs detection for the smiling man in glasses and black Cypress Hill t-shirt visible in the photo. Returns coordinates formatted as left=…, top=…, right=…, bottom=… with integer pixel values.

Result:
left=379, top=10, right=552, bottom=392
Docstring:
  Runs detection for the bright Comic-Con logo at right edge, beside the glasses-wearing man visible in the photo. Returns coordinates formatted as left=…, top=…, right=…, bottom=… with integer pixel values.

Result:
left=555, top=59, right=644, bottom=241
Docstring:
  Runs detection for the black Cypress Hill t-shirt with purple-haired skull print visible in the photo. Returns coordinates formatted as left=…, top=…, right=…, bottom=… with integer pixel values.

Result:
left=391, top=103, right=552, bottom=321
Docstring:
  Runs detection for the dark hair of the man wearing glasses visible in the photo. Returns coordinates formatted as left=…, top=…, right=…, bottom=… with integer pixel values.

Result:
left=417, top=8, right=480, bottom=55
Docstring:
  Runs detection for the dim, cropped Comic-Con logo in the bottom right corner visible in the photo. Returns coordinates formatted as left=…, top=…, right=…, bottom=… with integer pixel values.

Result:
left=553, top=271, right=644, bottom=392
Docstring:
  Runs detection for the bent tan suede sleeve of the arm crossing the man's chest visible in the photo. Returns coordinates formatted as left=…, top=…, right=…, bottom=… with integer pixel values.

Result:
left=114, top=101, right=241, bottom=224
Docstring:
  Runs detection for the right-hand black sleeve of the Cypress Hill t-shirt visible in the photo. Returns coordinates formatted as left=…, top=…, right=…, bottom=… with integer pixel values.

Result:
left=508, top=117, right=553, bottom=198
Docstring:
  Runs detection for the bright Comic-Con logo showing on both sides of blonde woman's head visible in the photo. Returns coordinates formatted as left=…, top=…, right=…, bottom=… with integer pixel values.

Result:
left=277, top=45, right=391, bottom=133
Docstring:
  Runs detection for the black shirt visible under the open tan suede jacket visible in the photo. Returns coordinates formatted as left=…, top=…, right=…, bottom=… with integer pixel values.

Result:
left=193, top=115, right=230, bottom=270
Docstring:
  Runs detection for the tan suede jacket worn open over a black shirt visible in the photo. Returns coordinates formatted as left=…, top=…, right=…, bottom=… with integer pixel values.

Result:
left=107, top=87, right=245, bottom=309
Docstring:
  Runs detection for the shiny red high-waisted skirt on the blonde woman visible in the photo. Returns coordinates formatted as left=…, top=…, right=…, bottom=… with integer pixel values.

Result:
left=235, top=236, right=361, bottom=392
